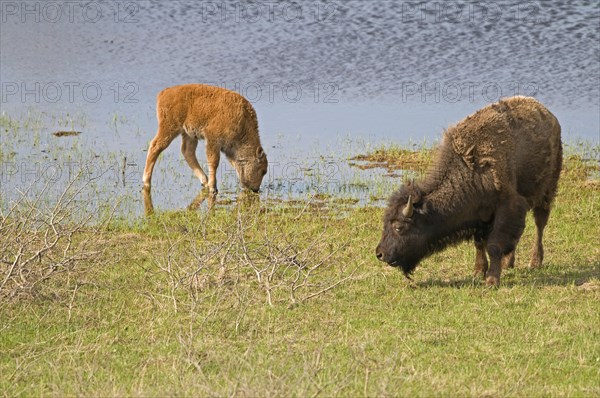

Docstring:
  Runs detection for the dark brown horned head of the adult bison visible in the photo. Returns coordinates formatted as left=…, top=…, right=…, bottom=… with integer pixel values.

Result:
left=375, top=184, right=431, bottom=277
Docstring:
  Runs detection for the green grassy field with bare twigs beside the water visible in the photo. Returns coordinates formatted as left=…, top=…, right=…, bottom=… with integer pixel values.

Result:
left=0, top=143, right=600, bottom=397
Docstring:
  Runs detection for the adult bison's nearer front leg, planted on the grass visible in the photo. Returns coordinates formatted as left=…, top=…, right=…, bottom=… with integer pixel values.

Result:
left=485, top=195, right=527, bottom=286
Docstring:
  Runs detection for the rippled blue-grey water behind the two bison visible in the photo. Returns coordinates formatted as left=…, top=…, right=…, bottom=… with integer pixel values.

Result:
left=0, top=1, right=600, bottom=213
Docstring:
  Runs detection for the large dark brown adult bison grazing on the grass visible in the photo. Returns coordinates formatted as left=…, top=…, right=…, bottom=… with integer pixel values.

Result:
left=376, top=96, right=562, bottom=286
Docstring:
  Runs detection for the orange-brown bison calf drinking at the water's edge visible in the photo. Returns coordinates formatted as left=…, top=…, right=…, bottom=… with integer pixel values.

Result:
left=144, top=84, right=268, bottom=194
